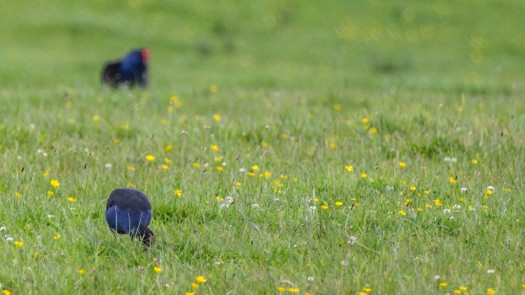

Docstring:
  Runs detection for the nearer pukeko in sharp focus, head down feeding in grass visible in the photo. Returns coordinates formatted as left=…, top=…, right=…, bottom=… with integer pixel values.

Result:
left=106, top=188, right=155, bottom=247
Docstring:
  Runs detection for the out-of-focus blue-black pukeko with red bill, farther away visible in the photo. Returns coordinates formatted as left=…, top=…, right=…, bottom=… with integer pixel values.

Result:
left=102, top=48, right=149, bottom=88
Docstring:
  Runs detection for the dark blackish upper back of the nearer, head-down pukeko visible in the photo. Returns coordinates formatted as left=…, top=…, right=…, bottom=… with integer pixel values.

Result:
left=106, top=188, right=151, bottom=211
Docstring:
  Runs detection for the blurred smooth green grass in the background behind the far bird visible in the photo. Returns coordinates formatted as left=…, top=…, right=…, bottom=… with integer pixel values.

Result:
left=0, top=0, right=525, bottom=94
